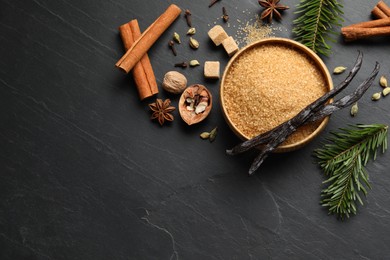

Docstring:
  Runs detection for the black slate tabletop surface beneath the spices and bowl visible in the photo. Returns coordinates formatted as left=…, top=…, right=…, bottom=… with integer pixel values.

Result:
left=0, top=0, right=390, bottom=259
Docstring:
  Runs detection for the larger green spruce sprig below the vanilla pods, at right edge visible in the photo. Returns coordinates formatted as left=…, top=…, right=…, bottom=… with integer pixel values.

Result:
left=314, top=124, right=388, bottom=219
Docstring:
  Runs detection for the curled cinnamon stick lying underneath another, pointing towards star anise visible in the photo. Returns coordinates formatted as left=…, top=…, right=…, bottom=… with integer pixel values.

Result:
left=119, top=20, right=158, bottom=100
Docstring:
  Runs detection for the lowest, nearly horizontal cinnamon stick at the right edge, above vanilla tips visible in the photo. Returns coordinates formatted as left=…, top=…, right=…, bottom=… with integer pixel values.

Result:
left=341, top=26, right=390, bottom=42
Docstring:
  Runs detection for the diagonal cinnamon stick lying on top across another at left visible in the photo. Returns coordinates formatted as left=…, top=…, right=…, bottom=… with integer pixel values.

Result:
left=115, top=4, right=181, bottom=73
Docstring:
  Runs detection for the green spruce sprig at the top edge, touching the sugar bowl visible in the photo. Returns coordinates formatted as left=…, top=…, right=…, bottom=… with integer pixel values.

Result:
left=293, top=0, right=344, bottom=56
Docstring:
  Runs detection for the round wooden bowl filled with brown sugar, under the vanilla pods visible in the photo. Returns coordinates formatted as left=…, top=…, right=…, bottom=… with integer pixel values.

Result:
left=220, top=38, right=333, bottom=152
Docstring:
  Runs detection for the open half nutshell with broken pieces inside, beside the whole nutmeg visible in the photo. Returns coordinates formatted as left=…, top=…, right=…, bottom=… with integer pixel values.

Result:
left=179, top=84, right=213, bottom=125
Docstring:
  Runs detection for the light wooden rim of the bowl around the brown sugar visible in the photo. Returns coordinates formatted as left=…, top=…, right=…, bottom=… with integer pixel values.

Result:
left=219, top=37, right=333, bottom=153
